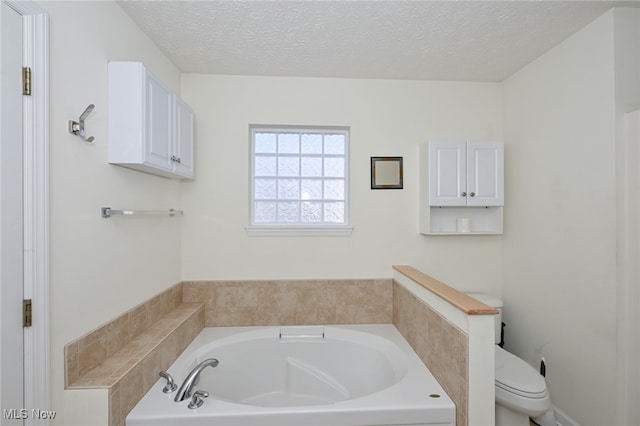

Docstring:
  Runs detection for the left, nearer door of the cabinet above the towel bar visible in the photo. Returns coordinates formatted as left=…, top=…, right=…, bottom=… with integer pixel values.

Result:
left=144, top=73, right=173, bottom=171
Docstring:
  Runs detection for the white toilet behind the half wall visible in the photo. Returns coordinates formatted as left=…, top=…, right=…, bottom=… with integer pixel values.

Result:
left=469, top=293, right=556, bottom=426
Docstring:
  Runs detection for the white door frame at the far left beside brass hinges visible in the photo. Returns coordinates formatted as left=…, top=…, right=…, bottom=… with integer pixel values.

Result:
left=2, top=0, right=51, bottom=425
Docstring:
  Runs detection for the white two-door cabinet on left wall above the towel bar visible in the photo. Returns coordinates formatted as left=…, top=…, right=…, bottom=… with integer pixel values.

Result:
left=109, top=62, right=193, bottom=178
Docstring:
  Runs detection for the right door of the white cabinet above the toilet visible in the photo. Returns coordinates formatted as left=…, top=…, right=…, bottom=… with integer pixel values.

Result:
left=467, top=142, right=504, bottom=206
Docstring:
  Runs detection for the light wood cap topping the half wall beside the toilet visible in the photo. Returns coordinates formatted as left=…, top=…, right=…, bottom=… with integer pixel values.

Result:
left=393, top=265, right=498, bottom=315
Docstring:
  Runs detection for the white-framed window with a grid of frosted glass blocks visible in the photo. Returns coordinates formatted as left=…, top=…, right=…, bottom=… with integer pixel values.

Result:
left=247, top=126, right=351, bottom=235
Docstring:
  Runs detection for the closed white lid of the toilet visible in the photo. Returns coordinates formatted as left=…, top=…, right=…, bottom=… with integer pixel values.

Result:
left=496, top=345, right=547, bottom=398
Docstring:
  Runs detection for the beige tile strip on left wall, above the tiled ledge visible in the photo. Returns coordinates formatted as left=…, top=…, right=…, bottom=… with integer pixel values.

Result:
left=64, top=283, right=182, bottom=387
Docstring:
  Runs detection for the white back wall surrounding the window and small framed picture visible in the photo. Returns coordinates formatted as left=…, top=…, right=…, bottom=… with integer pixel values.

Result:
left=182, top=75, right=509, bottom=292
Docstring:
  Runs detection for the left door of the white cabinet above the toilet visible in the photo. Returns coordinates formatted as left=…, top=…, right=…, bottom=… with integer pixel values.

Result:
left=428, top=141, right=467, bottom=206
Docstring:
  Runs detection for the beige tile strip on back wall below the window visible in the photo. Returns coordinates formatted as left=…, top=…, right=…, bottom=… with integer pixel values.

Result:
left=183, top=279, right=393, bottom=327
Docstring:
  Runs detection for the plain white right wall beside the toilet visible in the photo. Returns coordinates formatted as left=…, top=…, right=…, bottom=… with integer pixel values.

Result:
left=502, top=9, right=638, bottom=426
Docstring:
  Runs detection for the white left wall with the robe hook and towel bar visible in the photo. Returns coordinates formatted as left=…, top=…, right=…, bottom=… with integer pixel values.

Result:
left=40, top=1, right=181, bottom=425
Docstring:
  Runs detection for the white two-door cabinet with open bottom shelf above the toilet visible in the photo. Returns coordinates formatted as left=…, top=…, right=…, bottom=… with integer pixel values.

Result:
left=420, top=141, right=504, bottom=235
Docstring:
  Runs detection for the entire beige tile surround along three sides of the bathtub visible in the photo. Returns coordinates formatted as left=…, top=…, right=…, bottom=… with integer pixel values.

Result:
left=65, top=274, right=476, bottom=426
